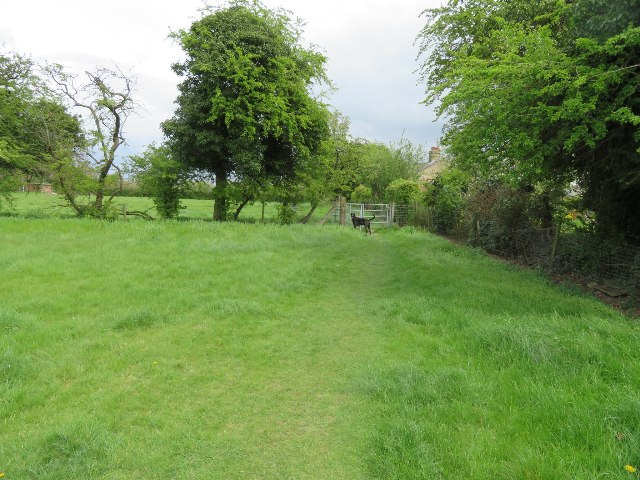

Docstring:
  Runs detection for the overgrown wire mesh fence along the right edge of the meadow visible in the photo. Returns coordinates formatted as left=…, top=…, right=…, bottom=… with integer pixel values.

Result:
left=408, top=204, right=640, bottom=309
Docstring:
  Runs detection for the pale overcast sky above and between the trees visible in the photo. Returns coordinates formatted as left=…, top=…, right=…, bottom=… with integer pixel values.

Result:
left=0, top=0, right=442, bottom=159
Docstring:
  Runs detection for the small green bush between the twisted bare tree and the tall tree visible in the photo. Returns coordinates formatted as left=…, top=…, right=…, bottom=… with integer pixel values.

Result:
left=129, top=145, right=191, bottom=219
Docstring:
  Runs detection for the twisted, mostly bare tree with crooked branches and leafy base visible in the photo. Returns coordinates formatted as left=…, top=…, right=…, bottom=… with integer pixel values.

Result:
left=47, top=65, right=136, bottom=217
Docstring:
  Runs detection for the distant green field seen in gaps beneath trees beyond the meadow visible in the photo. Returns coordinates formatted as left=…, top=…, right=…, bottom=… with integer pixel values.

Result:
left=1, top=192, right=329, bottom=222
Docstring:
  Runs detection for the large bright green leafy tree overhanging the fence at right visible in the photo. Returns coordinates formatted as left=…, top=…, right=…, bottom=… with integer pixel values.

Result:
left=420, top=0, right=640, bottom=235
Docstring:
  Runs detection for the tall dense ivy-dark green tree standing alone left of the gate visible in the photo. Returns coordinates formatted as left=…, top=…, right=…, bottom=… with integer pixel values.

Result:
left=163, top=0, right=328, bottom=220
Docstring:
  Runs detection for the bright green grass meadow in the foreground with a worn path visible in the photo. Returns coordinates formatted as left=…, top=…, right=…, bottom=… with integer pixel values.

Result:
left=0, top=217, right=640, bottom=480
